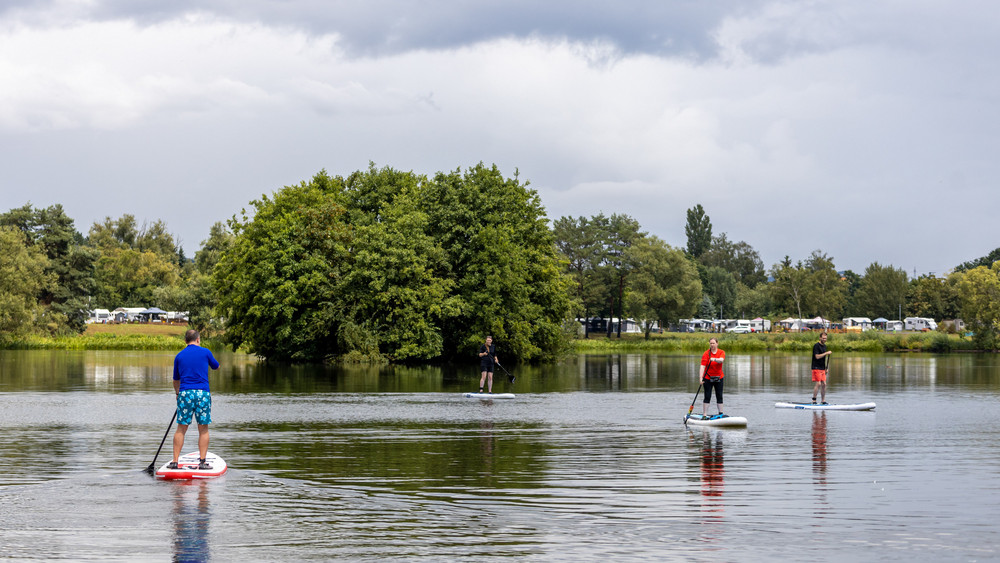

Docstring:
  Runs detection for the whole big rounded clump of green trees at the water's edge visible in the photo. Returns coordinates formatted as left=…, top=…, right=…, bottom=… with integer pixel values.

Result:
left=213, top=164, right=570, bottom=361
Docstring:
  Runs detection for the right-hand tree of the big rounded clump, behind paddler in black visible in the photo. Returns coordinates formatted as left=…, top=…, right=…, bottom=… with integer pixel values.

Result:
left=420, top=164, right=573, bottom=359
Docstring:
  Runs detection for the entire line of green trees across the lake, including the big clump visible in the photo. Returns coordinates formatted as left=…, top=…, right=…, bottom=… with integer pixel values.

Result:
left=0, top=164, right=1000, bottom=362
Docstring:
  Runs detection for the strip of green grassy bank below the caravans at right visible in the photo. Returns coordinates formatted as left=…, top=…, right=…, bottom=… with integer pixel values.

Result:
left=573, top=331, right=979, bottom=353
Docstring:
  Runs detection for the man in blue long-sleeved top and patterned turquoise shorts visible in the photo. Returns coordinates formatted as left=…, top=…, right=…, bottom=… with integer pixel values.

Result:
left=167, top=329, right=219, bottom=469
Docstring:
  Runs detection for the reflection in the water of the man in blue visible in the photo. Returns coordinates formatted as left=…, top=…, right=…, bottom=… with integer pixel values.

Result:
left=170, top=480, right=212, bottom=563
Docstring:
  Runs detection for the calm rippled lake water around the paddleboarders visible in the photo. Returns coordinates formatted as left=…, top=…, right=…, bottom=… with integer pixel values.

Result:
left=0, top=351, right=1000, bottom=562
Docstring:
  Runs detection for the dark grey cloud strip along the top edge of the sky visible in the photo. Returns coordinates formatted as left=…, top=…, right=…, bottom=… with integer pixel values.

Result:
left=7, top=0, right=765, bottom=60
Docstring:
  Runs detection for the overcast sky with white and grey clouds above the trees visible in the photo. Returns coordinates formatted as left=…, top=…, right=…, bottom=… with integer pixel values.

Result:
left=0, top=0, right=1000, bottom=275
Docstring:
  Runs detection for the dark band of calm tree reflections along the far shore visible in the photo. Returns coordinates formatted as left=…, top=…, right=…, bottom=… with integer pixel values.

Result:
left=0, top=350, right=1000, bottom=395
